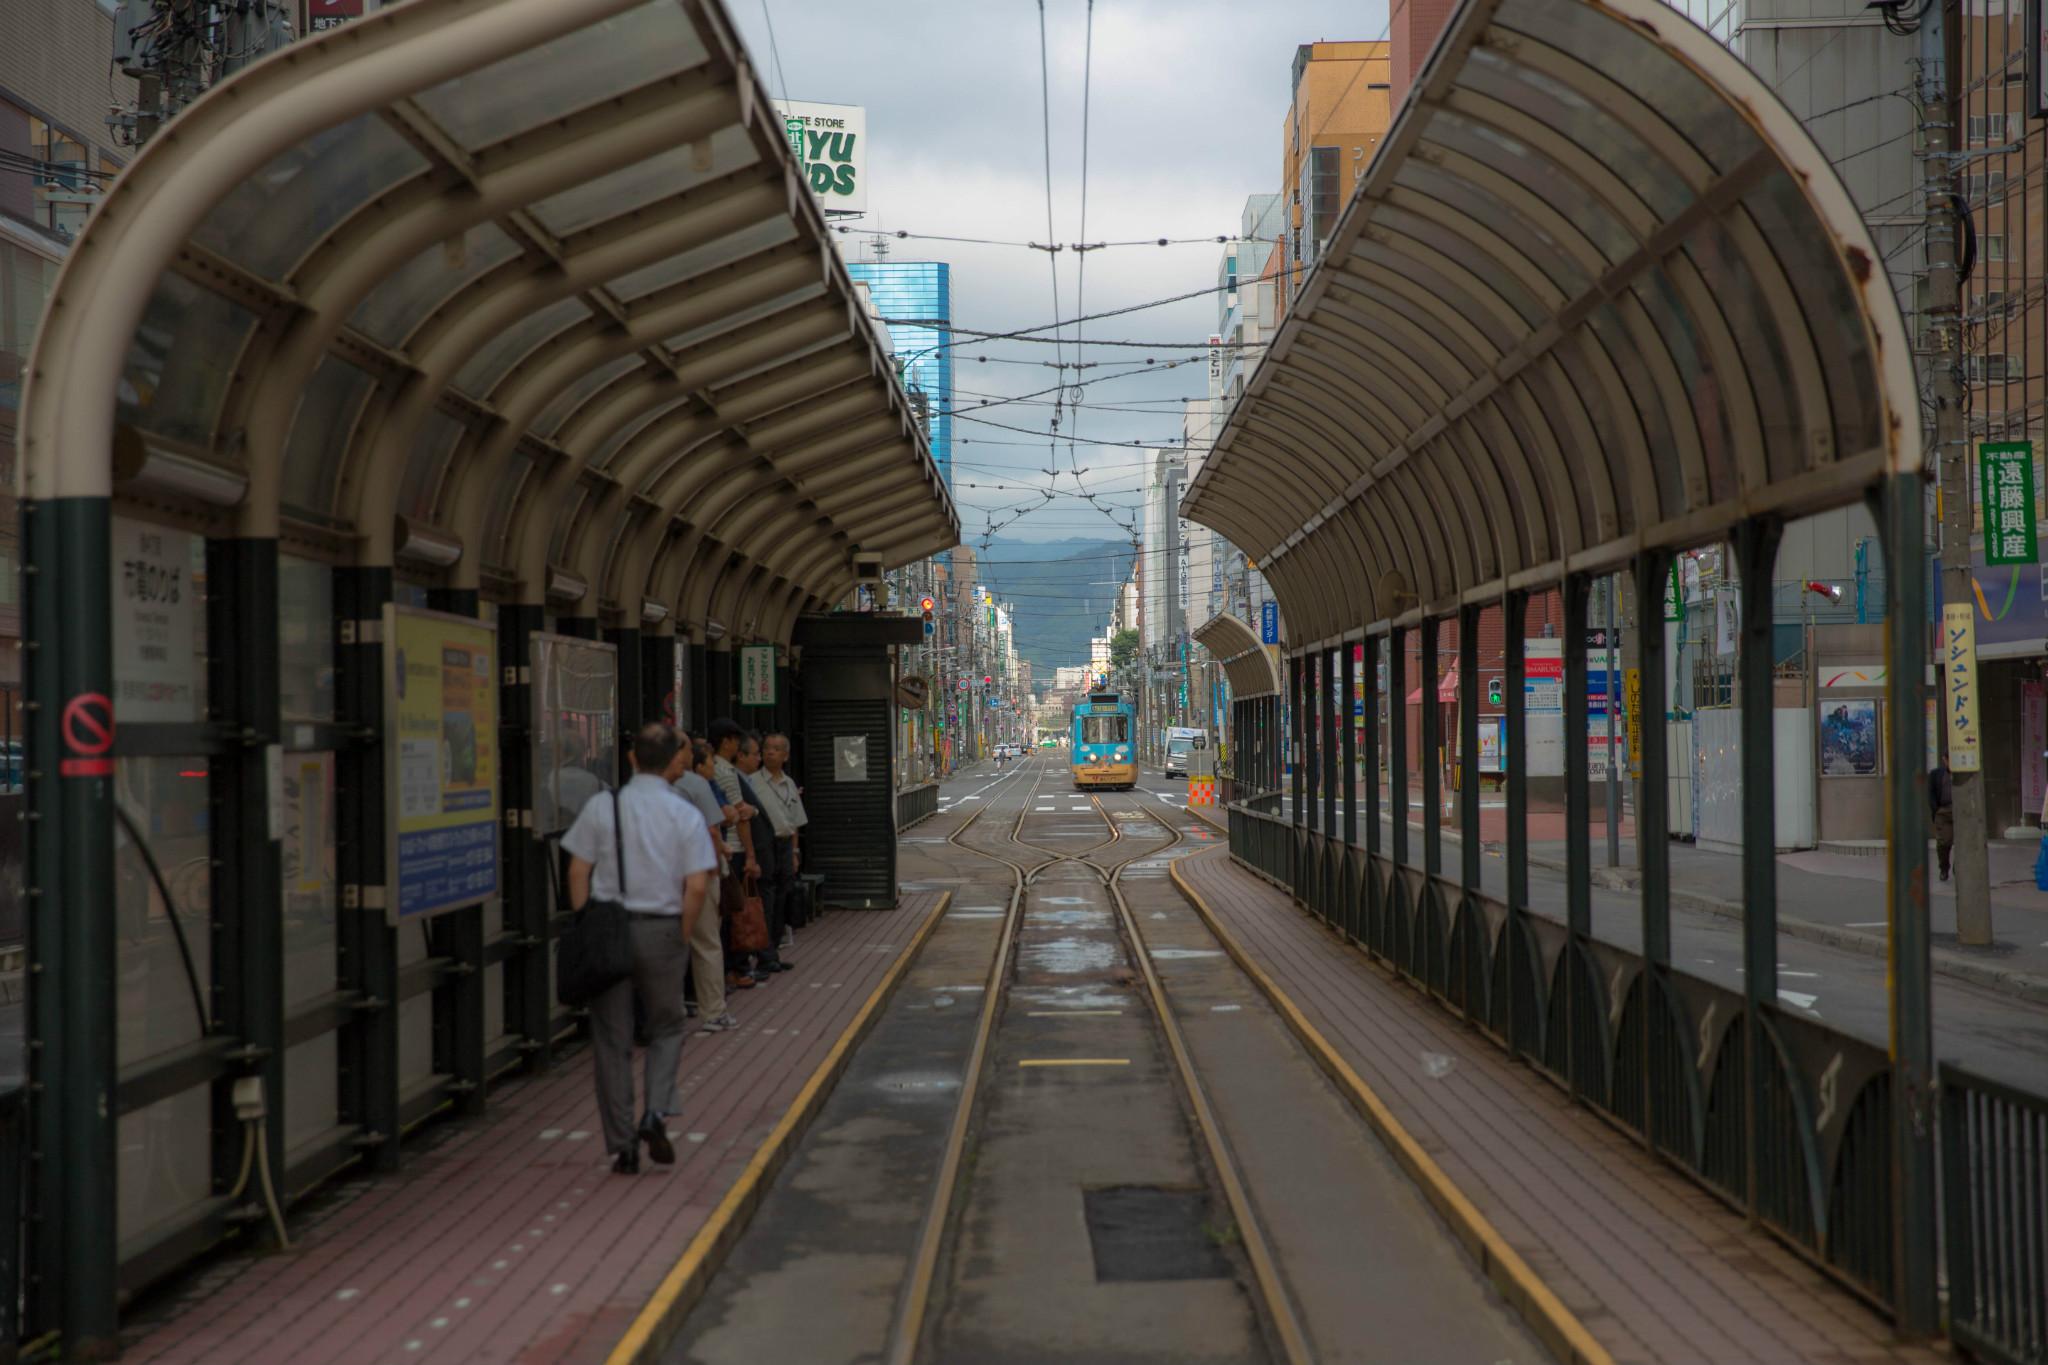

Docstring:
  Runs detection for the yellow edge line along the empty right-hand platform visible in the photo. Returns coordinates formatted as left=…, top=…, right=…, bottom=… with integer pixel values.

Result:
left=1167, top=806, right=1614, bottom=1365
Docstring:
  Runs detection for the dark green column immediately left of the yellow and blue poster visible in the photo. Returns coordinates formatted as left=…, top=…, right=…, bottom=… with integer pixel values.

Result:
left=334, top=565, right=399, bottom=1171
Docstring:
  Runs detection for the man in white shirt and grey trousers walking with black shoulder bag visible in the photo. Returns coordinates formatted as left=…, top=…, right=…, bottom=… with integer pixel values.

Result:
left=561, top=720, right=719, bottom=1175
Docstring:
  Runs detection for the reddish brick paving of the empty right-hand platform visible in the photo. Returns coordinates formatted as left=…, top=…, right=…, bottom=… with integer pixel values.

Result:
left=1180, top=847, right=1948, bottom=1363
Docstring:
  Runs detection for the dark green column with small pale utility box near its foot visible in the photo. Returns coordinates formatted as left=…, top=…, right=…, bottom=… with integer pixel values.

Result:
left=207, top=538, right=287, bottom=1227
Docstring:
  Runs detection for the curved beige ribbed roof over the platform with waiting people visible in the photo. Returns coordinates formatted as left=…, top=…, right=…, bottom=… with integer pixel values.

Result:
left=23, top=0, right=958, bottom=639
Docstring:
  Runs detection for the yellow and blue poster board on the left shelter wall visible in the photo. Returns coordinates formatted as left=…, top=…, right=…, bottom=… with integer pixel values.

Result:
left=385, top=606, right=498, bottom=923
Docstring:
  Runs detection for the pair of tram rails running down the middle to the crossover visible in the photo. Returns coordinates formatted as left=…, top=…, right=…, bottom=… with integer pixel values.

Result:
left=885, top=759, right=1311, bottom=1365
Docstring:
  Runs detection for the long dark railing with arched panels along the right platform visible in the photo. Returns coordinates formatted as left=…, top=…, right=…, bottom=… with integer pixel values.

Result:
left=1229, top=804, right=1900, bottom=1317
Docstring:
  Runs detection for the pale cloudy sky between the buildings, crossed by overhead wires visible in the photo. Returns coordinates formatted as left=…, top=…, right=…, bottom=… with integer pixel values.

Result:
left=729, top=0, right=1386, bottom=544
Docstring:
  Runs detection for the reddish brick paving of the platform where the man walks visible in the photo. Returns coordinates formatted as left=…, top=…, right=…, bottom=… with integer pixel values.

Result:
left=123, top=892, right=942, bottom=1365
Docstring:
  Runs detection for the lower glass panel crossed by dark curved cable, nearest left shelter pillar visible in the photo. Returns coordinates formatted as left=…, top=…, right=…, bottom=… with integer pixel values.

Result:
left=115, top=757, right=213, bottom=1066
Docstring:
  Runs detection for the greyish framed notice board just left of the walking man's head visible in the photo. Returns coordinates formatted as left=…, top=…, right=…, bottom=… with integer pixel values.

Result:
left=528, top=630, right=621, bottom=839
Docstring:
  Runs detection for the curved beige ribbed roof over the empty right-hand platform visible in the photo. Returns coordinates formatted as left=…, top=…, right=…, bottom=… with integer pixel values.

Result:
left=1182, top=0, right=1921, bottom=643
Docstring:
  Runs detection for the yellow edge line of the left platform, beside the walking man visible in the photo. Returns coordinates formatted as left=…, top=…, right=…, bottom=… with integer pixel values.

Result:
left=604, top=890, right=952, bottom=1365
